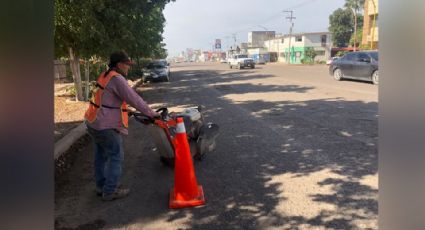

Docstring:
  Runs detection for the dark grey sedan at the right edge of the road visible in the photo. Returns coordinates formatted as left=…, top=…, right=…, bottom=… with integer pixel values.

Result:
left=329, top=51, right=379, bottom=85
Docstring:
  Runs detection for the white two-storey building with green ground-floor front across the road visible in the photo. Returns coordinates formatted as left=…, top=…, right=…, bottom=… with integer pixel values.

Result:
left=264, top=32, right=332, bottom=64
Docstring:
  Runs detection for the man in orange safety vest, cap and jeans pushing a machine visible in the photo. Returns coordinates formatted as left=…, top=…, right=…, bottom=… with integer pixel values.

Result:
left=84, top=51, right=159, bottom=201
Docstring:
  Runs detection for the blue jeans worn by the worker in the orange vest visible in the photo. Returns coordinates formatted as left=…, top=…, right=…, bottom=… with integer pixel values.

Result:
left=87, top=126, right=124, bottom=195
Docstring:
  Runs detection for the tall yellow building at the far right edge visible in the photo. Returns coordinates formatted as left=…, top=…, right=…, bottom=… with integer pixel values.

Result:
left=362, top=0, right=379, bottom=49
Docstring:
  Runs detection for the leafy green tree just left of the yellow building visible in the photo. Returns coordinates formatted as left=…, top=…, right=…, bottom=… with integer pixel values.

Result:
left=329, top=8, right=353, bottom=47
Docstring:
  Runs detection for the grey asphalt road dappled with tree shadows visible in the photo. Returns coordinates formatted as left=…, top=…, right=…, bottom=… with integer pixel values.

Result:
left=55, top=63, right=378, bottom=229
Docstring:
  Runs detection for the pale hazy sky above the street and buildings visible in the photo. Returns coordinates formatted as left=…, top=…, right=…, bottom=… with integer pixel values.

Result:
left=163, top=0, right=345, bottom=56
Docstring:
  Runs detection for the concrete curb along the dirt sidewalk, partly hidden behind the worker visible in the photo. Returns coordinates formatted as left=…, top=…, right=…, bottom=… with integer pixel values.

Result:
left=54, top=79, right=143, bottom=160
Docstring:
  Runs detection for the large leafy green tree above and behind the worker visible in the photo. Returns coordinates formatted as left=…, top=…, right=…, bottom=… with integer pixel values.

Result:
left=54, top=0, right=174, bottom=100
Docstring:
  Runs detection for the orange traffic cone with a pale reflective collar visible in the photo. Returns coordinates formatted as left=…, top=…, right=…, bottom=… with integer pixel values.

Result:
left=169, top=117, right=205, bottom=208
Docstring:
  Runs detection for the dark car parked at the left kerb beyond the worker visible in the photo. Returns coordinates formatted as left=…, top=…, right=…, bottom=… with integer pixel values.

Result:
left=143, top=60, right=170, bottom=82
